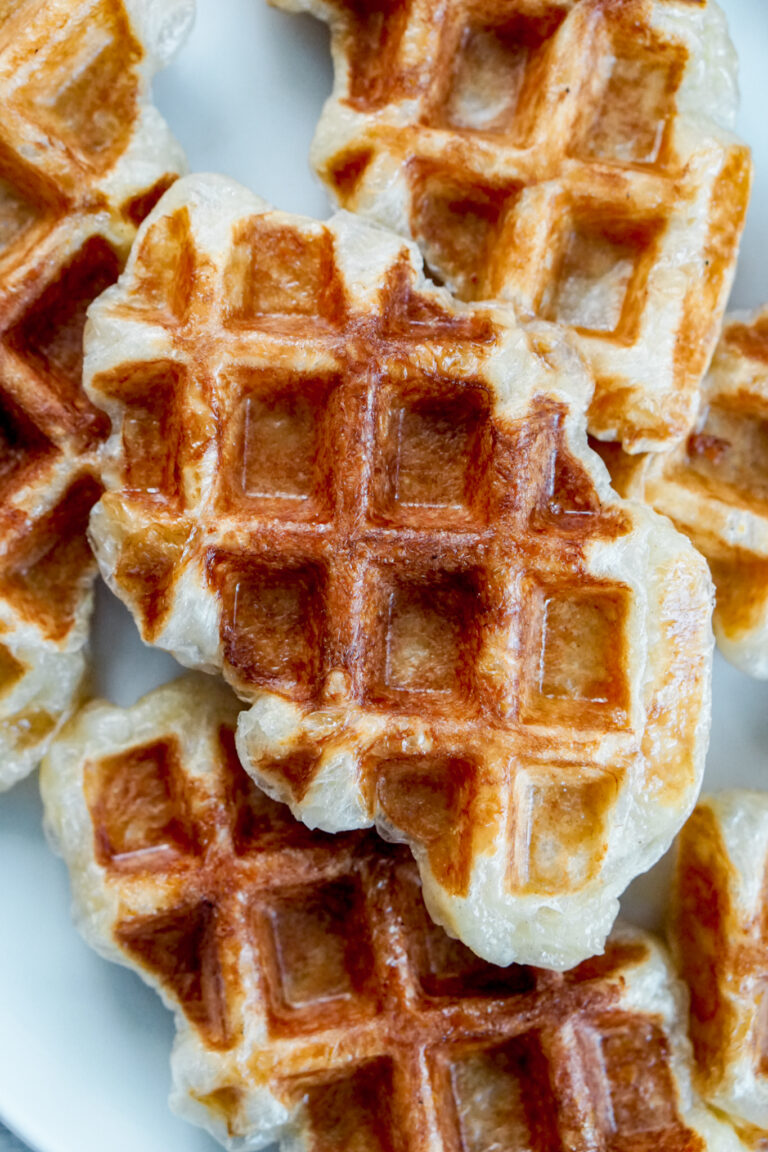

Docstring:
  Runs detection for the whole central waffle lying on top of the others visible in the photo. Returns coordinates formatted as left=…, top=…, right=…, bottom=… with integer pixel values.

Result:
left=85, top=177, right=712, bottom=968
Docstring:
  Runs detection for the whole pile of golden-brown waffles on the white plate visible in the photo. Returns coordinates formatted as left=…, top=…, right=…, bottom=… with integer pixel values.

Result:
left=0, top=0, right=768, bottom=1152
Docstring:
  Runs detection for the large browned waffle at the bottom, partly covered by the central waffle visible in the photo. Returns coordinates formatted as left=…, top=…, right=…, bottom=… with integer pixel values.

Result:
left=43, top=677, right=738, bottom=1152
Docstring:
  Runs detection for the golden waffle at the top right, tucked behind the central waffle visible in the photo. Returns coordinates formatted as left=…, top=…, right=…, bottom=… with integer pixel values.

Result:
left=274, top=0, right=751, bottom=452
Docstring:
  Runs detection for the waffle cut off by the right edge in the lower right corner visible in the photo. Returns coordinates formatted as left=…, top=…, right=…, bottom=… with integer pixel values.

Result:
left=669, top=791, right=768, bottom=1147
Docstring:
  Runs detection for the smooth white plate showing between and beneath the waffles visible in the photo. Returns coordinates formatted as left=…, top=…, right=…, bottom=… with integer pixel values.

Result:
left=0, top=0, right=768, bottom=1152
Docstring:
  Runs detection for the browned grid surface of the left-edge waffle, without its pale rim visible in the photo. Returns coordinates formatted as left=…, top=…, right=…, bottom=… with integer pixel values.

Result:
left=0, top=0, right=200, bottom=723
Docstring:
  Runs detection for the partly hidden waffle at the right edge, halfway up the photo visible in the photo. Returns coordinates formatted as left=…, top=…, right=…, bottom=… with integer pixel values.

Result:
left=594, top=309, right=768, bottom=677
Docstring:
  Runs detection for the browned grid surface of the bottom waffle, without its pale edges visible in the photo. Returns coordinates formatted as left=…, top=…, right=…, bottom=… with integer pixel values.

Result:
left=85, top=727, right=702, bottom=1152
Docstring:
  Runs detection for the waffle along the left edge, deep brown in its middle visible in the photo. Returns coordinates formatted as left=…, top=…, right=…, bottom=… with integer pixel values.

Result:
left=0, top=0, right=193, bottom=789
